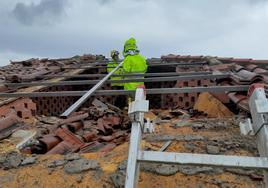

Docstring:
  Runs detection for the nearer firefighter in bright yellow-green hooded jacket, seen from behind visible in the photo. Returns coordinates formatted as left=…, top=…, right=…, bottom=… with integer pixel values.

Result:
left=123, top=38, right=147, bottom=92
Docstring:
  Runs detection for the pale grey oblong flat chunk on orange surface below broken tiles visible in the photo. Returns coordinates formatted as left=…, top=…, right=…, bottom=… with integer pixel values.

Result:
left=64, top=159, right=100, bottom=174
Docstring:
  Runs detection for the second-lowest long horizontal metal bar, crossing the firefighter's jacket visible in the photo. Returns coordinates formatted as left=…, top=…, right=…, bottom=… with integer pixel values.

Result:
left=4, top=74, right=230, bottom=87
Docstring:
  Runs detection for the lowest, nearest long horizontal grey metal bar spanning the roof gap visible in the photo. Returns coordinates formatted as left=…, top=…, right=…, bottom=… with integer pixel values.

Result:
left=0, top=85, right=249, bottom=98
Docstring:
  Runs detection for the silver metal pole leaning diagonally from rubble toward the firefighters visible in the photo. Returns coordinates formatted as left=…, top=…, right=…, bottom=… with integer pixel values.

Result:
left=61, top=61, right=123, bottom=117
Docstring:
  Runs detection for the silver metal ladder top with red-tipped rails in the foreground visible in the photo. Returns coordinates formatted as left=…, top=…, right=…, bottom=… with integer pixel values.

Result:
left=125, top=88, right=268, bottom=188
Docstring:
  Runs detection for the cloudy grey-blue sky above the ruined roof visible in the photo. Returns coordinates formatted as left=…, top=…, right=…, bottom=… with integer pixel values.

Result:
left=0, top=0, right=268, bottom=65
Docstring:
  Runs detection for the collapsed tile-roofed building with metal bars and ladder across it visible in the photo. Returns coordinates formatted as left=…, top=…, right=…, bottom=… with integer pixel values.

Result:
left=0, top=54, right=268, bottom=188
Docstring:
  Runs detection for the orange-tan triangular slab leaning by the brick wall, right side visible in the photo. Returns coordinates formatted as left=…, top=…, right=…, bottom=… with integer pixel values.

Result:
left=194, top=92, right=234, bottom=117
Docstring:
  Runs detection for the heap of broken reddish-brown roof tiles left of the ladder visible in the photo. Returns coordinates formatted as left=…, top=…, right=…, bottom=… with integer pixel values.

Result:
left=23, top=99, right=130, bottom=154
